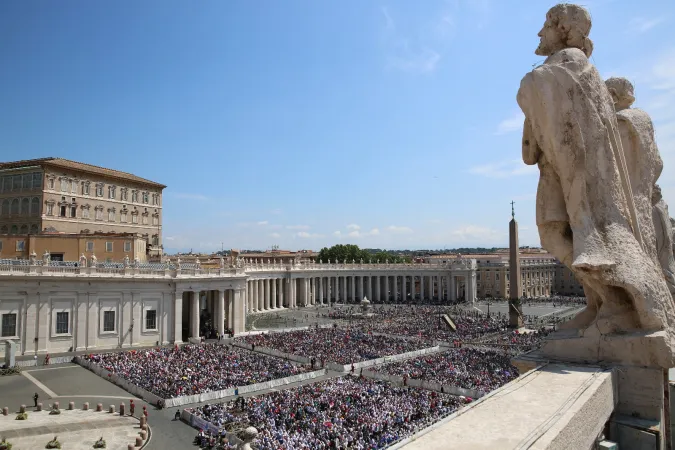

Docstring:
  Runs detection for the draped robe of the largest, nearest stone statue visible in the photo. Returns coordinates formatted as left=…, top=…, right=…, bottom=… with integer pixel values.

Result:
left=517, top=48, right=675, bottom=330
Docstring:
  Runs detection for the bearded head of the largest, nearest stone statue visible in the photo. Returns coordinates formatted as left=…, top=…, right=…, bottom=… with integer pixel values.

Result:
left=534, top=3, right=593, bottom=58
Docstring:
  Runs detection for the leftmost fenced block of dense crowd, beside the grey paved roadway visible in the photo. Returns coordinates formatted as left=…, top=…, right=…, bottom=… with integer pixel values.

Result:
left=84, top=344, right=305, bottom=399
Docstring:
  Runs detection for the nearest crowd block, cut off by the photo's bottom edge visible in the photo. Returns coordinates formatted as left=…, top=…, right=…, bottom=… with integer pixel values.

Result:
left=192, top=376, right=465, bottom=450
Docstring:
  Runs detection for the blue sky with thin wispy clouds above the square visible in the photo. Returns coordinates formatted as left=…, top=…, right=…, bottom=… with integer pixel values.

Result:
left=0, top=0, right=675, bottom=251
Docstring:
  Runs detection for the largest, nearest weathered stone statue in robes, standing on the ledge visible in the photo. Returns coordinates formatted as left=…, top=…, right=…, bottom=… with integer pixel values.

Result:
left=517, top=4, right=675, bottom=342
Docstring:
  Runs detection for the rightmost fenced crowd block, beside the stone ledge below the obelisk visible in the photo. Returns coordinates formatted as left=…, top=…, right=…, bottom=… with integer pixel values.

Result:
left=374, top=348, right=518, bottom=392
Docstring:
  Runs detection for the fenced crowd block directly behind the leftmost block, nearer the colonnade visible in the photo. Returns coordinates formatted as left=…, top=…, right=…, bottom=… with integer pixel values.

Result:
left=236, top=327, right=425, bottom=364
